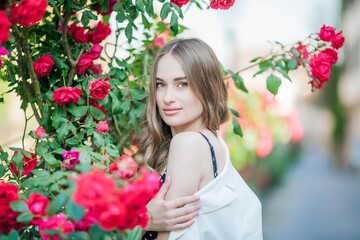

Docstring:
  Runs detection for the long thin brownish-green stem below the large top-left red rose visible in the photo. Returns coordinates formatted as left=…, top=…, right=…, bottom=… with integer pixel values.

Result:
left=23, top=27, right=43, bottom=113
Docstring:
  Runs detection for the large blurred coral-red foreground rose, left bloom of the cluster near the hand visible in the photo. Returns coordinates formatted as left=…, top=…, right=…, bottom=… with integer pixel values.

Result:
left=73, top=169, right=116, bottom=208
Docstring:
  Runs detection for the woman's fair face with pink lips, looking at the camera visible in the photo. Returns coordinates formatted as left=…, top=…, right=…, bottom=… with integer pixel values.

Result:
left=156, top=54, right=204, bottom=136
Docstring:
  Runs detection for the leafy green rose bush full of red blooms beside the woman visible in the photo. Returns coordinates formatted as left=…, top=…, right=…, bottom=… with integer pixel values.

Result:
left=0, top=0, right=344, bottom=239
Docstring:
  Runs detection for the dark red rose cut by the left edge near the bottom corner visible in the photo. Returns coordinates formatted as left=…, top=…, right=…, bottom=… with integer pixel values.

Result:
left=0, top=181, right=22, bottom=233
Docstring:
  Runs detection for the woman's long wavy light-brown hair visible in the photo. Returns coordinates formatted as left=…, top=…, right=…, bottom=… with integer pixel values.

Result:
left=138, top=38, right=229, bottom=172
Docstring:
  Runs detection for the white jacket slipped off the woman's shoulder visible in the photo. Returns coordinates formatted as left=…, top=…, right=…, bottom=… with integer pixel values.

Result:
left=168, top=134, right=263, bottom=240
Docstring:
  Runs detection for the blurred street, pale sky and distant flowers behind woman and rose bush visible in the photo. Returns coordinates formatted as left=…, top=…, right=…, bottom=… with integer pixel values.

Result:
left=0, top=0, right=360, bottom=240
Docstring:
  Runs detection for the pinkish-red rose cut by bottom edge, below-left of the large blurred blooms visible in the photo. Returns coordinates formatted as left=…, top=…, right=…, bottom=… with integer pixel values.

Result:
left=39, top=213, right=75, bottom=240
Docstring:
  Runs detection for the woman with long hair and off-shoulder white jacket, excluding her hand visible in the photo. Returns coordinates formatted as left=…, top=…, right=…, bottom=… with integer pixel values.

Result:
left=140, top=39, right=262, bottom=240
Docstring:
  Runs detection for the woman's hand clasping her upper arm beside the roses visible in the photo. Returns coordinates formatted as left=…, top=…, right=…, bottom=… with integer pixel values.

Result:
left=146, top=177, right=200, bottom=231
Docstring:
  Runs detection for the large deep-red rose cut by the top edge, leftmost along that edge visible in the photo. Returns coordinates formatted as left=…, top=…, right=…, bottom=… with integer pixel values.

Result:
left=10, top=0, right=47, bottom=26
